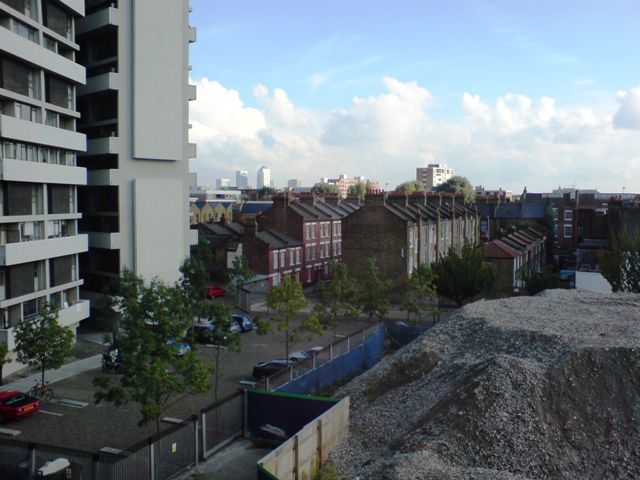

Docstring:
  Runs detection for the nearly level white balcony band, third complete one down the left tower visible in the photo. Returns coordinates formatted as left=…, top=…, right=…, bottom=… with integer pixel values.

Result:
left=0, top=158, right=87, bottom=185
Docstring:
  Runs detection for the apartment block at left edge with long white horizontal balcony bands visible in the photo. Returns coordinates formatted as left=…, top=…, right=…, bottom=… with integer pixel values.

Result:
left=0, top=0, right=91, bottom=374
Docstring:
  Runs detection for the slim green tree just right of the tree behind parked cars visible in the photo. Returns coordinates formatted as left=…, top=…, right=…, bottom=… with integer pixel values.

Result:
left=313, top=262, right=359, bottom=339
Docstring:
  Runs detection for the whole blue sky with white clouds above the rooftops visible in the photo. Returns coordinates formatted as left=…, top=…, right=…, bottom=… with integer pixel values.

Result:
left=190, top=0, right=640, bottom=193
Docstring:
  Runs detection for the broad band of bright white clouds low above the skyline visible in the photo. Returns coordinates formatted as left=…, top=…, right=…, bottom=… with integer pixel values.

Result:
left=191, top=77, right=640, bottom=191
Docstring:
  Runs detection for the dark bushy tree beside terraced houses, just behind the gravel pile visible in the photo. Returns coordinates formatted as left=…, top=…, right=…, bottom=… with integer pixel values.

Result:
left=433, top=244, right=495, bottom=307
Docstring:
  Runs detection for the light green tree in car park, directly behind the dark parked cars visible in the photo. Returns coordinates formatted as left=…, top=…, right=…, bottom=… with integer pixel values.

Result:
left=258, top=275, right=322, bottom=358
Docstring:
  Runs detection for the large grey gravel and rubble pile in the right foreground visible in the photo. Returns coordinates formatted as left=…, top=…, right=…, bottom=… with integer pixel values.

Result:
left=330, top=290, right=640, bottom=480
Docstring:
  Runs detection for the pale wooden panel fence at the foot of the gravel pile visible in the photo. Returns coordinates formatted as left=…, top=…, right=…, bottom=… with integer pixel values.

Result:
left=258, top=397, right=349, bottom=480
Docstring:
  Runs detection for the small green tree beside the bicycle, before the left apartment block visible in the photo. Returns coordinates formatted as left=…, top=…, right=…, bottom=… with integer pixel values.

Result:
left=14, top=303, right=73, bottom=390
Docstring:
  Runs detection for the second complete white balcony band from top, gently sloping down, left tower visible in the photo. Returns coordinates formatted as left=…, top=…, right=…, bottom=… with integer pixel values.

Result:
left=0, top=114, right=87, bottom=152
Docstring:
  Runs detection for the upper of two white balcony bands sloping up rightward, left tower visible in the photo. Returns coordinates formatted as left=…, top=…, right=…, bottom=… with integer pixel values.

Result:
left=0, top=234, right=89, bottom=266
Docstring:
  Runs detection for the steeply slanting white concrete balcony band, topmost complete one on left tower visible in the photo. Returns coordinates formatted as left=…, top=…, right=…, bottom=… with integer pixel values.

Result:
left=0, top=28, right=85, bottom=84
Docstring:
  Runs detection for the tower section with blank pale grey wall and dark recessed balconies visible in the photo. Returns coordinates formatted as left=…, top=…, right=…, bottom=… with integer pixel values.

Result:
left=75, top=0, right=197, bottom=296
